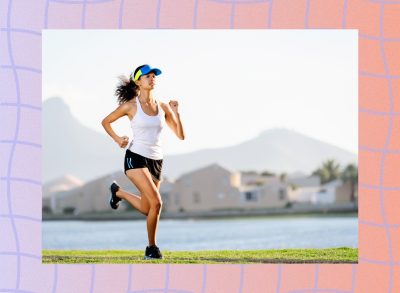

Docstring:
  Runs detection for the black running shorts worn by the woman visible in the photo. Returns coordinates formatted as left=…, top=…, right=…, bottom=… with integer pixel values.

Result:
left=124, top=149, right=163, bottom=181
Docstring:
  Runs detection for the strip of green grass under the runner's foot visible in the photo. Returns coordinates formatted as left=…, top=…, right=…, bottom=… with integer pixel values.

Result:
left=42, top=247, right=358, bottom=264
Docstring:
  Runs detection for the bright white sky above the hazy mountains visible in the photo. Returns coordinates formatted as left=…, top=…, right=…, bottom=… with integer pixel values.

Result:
left=42, top=29, right=358, bottom=154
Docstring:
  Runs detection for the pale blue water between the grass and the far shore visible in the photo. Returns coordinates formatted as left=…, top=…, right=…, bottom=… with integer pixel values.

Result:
left=42, top=216, right=358, bottom=251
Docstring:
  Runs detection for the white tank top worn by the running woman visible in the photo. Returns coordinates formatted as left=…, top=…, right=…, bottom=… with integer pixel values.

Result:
left=129, top=98, right=165, bottom=160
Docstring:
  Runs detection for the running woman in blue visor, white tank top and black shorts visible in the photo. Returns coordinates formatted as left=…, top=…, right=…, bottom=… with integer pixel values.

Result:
left=102, top=64, right=185, bottom=259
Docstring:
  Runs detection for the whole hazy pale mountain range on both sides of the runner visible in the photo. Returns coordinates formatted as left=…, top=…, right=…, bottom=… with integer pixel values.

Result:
left=43, top=98, right=357, bottom=182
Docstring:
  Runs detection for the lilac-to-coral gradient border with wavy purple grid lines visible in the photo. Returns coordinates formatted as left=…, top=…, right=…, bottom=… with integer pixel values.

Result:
left=0, top=0, right=400, bottom=293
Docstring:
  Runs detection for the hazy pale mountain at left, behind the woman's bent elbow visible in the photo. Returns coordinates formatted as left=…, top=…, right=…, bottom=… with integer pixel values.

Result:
left=42, top=98, right=125, bottom=183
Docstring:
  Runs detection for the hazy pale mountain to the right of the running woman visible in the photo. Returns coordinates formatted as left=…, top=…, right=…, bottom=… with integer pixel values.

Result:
left=165, top=128, right=357, bottom=178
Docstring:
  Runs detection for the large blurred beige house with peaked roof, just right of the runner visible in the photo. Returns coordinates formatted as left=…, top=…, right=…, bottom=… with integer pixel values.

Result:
left=164, top=164, right=288, bottom=212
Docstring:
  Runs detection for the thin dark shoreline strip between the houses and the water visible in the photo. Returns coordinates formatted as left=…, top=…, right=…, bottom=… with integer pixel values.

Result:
left=42, top=204, right=358, bottom=221
